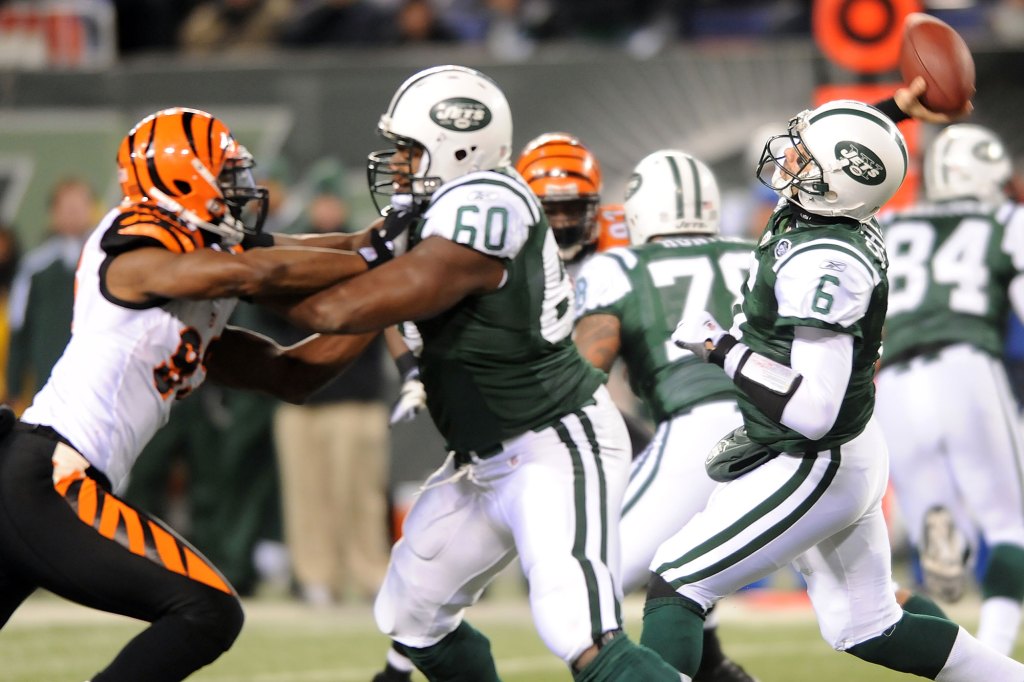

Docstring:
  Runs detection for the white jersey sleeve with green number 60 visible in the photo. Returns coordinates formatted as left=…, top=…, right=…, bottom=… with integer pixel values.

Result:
left=420, top=171, right=541, bottom=258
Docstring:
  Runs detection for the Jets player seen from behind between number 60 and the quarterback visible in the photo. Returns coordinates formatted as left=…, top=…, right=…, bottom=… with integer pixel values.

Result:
left=574, top=150, right=754, bottom=682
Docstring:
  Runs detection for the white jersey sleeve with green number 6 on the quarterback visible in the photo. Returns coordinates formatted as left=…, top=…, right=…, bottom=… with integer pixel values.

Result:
left=775, top=240, right=881, bottom=329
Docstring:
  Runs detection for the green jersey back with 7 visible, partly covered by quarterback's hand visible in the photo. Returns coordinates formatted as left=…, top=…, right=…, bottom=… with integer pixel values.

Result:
left=575, top=237, right=754, bottom=422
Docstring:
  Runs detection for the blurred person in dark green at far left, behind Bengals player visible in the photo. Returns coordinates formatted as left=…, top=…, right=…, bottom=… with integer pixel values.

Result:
left=7, top=177, right=97, bottom=407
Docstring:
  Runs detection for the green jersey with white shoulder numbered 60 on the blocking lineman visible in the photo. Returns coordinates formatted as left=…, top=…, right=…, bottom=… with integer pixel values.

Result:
left=411, top=171, right=604, bottom=453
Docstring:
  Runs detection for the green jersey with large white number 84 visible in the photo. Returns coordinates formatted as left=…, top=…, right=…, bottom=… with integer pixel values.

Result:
left=882, top=196, right=1024, bottom=364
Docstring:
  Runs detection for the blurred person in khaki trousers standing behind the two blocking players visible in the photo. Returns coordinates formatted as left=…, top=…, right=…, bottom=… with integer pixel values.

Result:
left=273, top=161, right=390, bottom=606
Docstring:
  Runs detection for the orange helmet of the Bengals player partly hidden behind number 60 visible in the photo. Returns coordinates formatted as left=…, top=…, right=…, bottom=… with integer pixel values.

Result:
left=515, top=132, right=601, bottom=261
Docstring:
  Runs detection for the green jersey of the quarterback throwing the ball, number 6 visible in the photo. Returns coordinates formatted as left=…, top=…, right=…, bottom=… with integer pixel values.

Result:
left=737, top=205, right=889, bottom=452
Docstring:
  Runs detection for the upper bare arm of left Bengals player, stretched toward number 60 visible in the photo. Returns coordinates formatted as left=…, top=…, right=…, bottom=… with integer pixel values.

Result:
left=105, top=240, right=367, bottom=303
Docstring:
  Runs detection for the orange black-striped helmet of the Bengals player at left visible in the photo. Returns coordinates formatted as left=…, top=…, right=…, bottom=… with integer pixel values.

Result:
left=117, top=108, right=267, bottom=246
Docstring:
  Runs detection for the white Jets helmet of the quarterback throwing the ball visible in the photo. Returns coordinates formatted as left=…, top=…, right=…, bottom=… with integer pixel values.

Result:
left=757, top=99, right=908, bottom=221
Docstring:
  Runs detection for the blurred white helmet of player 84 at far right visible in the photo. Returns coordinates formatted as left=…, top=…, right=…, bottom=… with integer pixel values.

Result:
left=925, top=123, right=1013, bottom=204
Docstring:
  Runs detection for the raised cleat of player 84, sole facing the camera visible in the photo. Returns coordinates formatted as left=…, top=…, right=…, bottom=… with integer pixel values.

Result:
left=921, top=507, right=967, bottom=602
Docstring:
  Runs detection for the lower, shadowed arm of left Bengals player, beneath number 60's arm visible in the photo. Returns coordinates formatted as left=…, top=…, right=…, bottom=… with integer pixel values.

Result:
left=205, top=327, right=377, bottom=403
